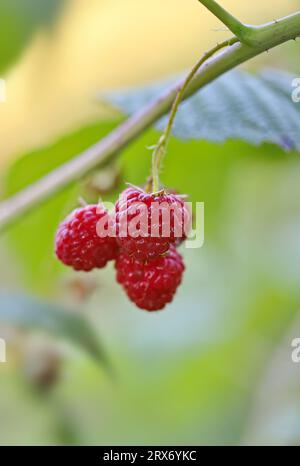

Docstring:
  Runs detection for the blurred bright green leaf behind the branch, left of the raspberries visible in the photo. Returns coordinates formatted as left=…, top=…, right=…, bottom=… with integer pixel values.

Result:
left=4, top=122, right=116, bottom=293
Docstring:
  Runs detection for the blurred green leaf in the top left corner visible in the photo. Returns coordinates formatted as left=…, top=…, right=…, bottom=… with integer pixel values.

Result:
left=0, top=0, right=63, bottom=72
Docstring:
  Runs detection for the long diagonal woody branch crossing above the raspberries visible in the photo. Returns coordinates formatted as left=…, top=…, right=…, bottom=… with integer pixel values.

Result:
left=0, top=12, right=300, bottom=229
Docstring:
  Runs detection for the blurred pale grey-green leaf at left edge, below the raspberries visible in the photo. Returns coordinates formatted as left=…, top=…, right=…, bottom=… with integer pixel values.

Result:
left=0, top=292, right=107, bottom=364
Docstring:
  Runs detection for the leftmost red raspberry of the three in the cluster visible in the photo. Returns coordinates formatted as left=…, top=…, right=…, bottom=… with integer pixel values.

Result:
left=55, top=205, right=118, bottom=272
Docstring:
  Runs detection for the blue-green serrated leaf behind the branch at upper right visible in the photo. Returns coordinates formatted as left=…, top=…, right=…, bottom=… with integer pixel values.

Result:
left=107, top=70, right=300, bottom=150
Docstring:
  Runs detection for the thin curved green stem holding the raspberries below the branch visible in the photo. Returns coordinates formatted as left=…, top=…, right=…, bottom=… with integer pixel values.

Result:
left=152, top=37, right=238, bottom=193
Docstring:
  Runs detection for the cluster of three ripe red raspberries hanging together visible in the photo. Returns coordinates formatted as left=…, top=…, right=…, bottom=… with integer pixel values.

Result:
left=55, top=187, right=191, bottom=311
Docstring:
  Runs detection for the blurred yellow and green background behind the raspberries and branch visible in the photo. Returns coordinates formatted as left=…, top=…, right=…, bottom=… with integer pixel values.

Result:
left=0, top=0, right=300, bottom=445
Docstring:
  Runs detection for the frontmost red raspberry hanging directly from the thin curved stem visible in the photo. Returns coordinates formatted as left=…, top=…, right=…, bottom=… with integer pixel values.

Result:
left=116, top=187, right=190, bottom=261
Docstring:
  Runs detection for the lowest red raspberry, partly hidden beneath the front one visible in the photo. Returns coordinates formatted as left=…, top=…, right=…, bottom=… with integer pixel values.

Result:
left=116, top=246, right=185, bottom=311
